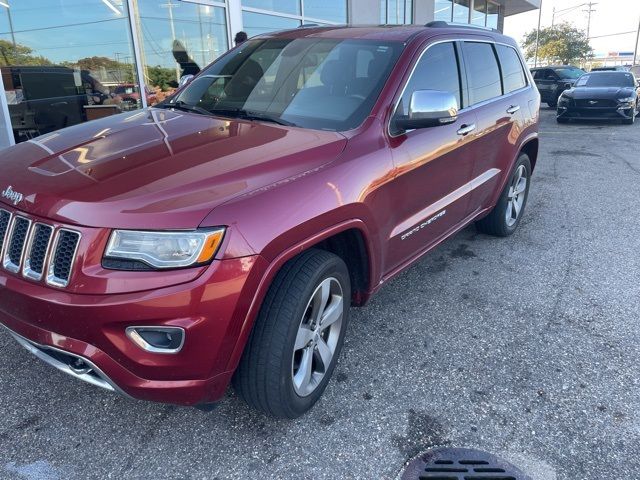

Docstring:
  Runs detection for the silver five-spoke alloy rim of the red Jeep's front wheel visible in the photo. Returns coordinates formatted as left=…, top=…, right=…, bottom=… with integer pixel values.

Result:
left=291, top=277, right=344, bottom=397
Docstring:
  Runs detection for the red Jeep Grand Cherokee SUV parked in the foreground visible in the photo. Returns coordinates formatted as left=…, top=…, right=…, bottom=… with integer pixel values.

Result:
left=0, top=22, right=540, bottom=418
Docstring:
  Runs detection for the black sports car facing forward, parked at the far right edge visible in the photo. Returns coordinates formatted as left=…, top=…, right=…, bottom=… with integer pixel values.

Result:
left=556, top=72, right=640, bottom=124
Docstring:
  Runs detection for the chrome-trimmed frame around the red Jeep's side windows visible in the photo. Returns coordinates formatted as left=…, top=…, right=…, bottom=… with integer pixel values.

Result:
left=386, top=37, right=534, bottom=138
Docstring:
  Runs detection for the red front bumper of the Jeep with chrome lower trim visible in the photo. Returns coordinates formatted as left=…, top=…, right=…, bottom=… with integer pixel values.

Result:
left=0, top=256, right=266, bottom=405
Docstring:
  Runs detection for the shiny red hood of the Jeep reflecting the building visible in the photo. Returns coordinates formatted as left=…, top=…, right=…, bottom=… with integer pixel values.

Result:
left=0, top=108, right=346, bottom=229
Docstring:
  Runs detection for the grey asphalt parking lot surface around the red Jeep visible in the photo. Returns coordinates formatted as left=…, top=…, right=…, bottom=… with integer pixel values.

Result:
left=0, top=108, right=640, bottom=480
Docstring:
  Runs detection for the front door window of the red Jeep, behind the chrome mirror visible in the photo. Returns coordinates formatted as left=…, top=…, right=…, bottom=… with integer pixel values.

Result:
left=396, top=42, right=462, bottom=115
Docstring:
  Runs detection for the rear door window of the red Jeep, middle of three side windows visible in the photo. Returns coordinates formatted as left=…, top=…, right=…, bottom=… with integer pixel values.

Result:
left=462, top=42, right=502, bottom=105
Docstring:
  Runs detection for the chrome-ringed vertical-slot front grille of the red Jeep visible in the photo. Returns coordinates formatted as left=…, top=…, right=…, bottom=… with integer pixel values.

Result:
left=0, top=209, right=80, bottom=287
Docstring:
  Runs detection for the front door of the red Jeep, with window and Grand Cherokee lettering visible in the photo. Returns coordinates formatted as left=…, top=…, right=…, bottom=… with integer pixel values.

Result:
left=386, top=41, right=476, bottom=272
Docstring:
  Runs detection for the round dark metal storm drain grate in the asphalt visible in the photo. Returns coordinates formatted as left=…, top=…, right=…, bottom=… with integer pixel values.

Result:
left=400, top=448, right=531, bottom=480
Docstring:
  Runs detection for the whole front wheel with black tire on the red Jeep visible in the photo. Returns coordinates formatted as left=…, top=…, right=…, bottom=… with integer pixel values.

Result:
left=233, top=249, right=351, bottom=418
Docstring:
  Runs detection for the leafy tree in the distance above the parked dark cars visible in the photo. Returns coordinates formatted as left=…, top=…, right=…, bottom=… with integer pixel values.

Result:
left=523, top=23, right=593, bottom=65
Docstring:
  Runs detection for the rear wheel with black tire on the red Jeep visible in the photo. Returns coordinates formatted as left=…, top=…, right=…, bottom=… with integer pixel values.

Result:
left=476, top=153, right=531, bottom=237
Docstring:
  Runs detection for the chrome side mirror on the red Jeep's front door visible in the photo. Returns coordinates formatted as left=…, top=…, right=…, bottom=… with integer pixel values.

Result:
left=394, top=90, right=458, bottom=130
